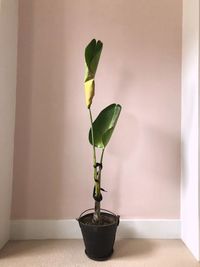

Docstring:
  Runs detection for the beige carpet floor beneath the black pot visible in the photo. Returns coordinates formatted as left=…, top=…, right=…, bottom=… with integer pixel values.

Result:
left=0, top=239, right=200, bottom=267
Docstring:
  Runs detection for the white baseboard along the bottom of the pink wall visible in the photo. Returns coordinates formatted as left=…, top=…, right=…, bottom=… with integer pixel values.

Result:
left=10, top=219, right=181, bottom=240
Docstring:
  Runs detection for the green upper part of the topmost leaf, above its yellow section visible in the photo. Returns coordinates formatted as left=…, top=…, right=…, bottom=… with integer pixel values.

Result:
left=85, top=39, right=103, bottom=81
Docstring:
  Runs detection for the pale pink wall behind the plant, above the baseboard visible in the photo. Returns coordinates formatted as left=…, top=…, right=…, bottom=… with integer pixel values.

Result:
left=12, top=0, right=182, bottom=219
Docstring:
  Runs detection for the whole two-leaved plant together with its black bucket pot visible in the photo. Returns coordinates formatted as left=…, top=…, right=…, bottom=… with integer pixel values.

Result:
left=77, top=39, right=121, bottom=260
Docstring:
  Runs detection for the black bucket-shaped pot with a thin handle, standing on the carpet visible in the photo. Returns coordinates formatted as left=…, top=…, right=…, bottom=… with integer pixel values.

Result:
left=77, top=209, right=119, bottom=261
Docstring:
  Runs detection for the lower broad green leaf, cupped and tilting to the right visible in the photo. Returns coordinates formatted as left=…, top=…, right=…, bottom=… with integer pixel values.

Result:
left=89, top=104, right=121, bottom=148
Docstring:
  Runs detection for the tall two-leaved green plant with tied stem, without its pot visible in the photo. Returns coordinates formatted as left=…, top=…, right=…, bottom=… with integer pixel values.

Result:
left=84, top=39, right=121, bottom=224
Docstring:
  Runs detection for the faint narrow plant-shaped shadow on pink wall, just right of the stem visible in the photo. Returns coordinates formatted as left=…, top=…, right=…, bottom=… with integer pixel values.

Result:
left=104, top=66, right=139, bottom=212
